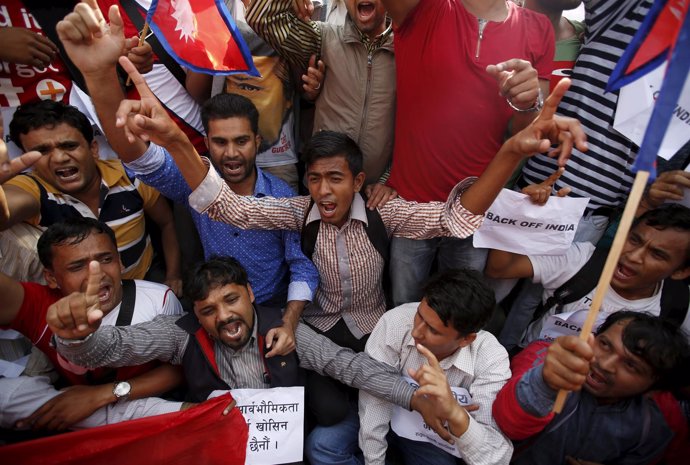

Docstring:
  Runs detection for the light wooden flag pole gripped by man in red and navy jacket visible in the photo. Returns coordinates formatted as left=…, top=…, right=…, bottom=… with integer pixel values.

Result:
left=553, top=170, right=649, bottom=413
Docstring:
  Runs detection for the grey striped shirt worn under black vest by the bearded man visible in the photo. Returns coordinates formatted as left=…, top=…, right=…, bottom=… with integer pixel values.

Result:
left=57, top=315, right=414, bottom=408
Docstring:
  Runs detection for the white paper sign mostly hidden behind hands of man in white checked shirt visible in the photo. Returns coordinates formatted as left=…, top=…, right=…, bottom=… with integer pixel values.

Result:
left=391, top=377, right=472, bottom=458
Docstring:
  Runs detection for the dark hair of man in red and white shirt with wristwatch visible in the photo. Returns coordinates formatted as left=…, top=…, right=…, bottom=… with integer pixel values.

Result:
left=36, top=216, right=117, bottom=270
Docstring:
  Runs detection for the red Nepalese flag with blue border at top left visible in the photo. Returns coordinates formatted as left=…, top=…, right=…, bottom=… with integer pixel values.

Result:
left=146, top=0, right=259, bottom=76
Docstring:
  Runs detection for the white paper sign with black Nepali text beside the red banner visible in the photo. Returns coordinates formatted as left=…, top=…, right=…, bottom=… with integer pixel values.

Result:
left=230, top=386, right=304, bottom=465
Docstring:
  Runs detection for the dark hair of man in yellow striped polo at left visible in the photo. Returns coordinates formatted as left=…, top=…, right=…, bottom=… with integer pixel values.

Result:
left=10, top=100, right=93, bottom=150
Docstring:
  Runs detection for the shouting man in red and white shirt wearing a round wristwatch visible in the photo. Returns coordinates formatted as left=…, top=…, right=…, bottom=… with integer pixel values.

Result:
left=0, top=218, right=182, bottom=430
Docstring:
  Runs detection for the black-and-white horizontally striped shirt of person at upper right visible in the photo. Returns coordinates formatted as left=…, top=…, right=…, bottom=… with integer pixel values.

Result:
left=523, top=0, right=652, bottom=209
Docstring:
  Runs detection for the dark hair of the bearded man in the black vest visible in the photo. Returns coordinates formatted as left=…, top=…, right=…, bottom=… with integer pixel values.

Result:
left=184, top=255, right=249, bottom=302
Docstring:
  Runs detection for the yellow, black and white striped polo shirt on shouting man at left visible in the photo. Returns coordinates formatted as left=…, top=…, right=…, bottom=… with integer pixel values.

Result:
left=6, top=160, right=160, bottom=279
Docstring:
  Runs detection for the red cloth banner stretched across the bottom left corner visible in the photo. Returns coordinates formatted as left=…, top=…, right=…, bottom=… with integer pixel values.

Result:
left=0, top=393, right=249, bottom=465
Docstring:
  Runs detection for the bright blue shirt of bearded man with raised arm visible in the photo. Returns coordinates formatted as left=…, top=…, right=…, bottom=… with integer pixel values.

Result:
left=125, top=144, right=319, bottom=305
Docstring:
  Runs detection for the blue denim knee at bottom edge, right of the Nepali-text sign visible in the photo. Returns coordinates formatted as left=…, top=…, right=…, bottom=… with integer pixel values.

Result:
left=304, top=401, right=364, bottom=465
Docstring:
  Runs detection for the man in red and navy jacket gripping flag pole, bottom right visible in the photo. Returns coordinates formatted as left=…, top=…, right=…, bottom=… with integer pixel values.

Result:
left=490, top=311, right=689, bottom=465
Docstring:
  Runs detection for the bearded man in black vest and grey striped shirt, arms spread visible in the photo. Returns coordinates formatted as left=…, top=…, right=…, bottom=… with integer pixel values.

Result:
left=47, top=257, right=424, bottom=438
